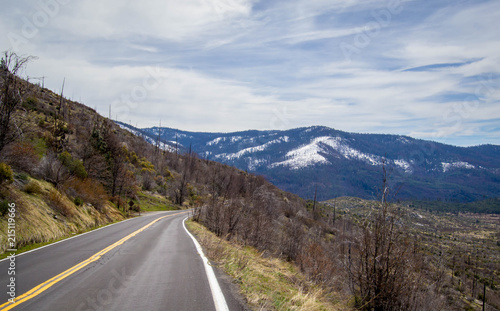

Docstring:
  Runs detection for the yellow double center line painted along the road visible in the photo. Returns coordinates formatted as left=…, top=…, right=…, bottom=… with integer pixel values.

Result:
left=0, top=212, right=186, bottom=311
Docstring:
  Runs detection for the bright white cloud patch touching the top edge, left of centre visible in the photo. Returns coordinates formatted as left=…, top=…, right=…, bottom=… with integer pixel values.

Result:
left=53, top=0, right=251, bottom=42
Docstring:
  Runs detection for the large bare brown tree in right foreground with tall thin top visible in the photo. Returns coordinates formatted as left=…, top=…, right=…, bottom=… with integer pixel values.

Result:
left=345, top=162, right=428, bottom=311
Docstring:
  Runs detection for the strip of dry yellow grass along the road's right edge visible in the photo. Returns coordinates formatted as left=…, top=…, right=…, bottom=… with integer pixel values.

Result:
left=187, top=221, right=351, bottom=311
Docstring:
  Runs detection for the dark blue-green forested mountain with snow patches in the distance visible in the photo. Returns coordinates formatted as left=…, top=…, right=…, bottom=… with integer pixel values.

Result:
left=119, top=123, right=500, bottom=202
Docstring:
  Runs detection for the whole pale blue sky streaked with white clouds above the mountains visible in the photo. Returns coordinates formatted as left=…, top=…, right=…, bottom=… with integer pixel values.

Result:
left=0, top=0, right=500, bottom=146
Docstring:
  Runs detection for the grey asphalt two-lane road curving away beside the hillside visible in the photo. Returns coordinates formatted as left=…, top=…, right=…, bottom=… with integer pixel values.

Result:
left=0, top=211, right=244, bottom=311
